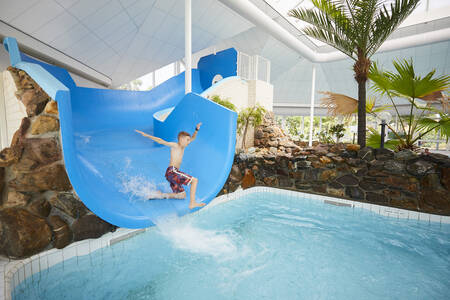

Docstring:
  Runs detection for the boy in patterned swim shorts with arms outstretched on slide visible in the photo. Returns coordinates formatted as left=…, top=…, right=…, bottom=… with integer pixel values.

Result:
left=135, top=123, right=205, bottom=209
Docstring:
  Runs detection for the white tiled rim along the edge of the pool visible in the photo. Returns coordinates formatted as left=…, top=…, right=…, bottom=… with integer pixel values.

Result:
left=0, top=187, right=450, bottom=300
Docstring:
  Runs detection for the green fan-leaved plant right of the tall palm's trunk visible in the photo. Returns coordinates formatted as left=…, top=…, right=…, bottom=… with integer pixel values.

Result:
left=369, top=59, right=450, bottom=150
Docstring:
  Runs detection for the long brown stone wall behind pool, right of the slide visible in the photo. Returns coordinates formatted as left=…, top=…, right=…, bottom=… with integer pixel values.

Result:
left=221, top=115, right=450, bottom=215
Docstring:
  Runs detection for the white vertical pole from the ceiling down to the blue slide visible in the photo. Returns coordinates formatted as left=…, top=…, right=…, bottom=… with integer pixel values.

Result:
left=184, top=0, right=192, bottom=94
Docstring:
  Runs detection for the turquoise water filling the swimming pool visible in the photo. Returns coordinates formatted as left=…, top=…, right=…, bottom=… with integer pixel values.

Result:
left=13, top=193, right=450, bottom=300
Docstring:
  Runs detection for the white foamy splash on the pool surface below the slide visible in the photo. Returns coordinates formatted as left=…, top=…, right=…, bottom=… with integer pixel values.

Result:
left=155, top=216, right=238, bottom=258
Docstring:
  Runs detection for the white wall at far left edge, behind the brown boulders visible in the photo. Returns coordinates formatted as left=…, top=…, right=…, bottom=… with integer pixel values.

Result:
left=0, top=71, right=27, bottom=149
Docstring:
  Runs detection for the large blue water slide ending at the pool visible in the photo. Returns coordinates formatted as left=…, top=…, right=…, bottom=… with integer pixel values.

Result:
left=3, top=38, right=237, bottom=228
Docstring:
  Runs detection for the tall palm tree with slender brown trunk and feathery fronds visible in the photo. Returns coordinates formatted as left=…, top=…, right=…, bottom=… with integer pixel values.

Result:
left=289, top=0, right=420, bottom=147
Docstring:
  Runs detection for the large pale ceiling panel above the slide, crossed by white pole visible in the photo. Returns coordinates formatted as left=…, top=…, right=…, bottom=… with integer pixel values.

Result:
left=0, top=0, right=253, bottom=84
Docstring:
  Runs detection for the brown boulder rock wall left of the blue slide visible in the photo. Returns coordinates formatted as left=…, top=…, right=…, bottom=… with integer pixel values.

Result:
left=0, top=68, right=115, bottom=258
